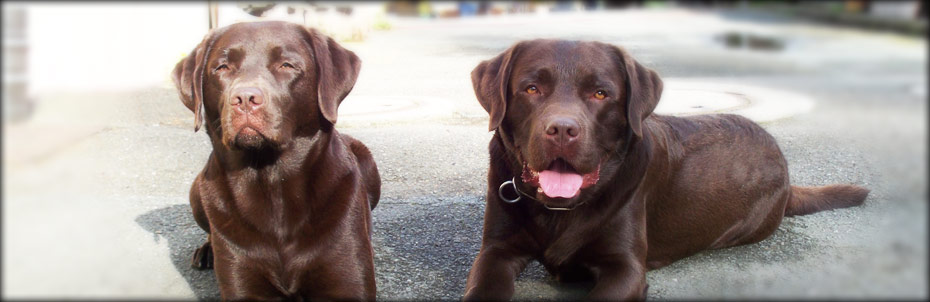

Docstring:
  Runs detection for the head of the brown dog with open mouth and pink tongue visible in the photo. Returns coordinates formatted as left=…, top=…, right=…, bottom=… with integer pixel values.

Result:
left=471, top=40, right=662, bottom=207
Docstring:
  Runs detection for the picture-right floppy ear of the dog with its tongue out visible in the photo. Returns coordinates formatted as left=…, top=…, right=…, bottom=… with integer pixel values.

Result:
left=610, top=45, right=662, bottom=137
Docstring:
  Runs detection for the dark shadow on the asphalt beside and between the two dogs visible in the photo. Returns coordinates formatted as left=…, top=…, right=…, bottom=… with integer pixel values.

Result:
left=136, top=197, right=591, bottom=301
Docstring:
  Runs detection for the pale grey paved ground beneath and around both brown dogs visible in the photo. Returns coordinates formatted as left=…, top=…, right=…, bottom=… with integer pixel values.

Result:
left=3, top=10, right=927, bottom=300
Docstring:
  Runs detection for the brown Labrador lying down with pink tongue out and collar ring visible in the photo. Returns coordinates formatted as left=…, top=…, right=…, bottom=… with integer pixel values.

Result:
left=465, top=40, right=868, bottom=300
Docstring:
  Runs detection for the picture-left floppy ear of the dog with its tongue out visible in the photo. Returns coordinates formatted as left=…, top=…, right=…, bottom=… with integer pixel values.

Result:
left=471, top=43, right=521, bottom=131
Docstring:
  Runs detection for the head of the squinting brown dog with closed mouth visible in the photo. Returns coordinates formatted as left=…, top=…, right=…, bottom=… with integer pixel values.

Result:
left=173, top=21, right=361, bottom=151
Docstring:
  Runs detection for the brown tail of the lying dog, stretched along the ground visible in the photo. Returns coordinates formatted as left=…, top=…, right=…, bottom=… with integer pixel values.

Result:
left=785, top=185, right=869, bottom=216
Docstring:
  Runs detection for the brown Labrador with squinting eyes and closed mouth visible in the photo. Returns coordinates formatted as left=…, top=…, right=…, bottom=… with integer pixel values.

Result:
left=174, top=22, right=381, bottom=300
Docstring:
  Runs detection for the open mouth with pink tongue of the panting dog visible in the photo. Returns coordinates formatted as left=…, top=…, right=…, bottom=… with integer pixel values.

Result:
left=521, top=158, right=601, bottom=198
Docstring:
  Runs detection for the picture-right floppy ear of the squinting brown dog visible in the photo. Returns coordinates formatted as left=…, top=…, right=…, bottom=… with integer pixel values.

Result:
left=307, top=29, right=362, bottom=124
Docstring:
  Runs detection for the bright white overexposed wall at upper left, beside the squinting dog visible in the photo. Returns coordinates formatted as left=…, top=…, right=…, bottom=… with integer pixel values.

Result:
left=27, top=2, right=209, bottom=95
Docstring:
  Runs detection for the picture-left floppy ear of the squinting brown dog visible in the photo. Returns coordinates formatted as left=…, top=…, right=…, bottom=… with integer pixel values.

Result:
left=171, top=30, right=221, bottom=132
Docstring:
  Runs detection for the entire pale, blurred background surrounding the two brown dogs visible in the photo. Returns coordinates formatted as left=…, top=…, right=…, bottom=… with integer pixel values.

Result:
left=2, top=1, right=927, bottom=300
